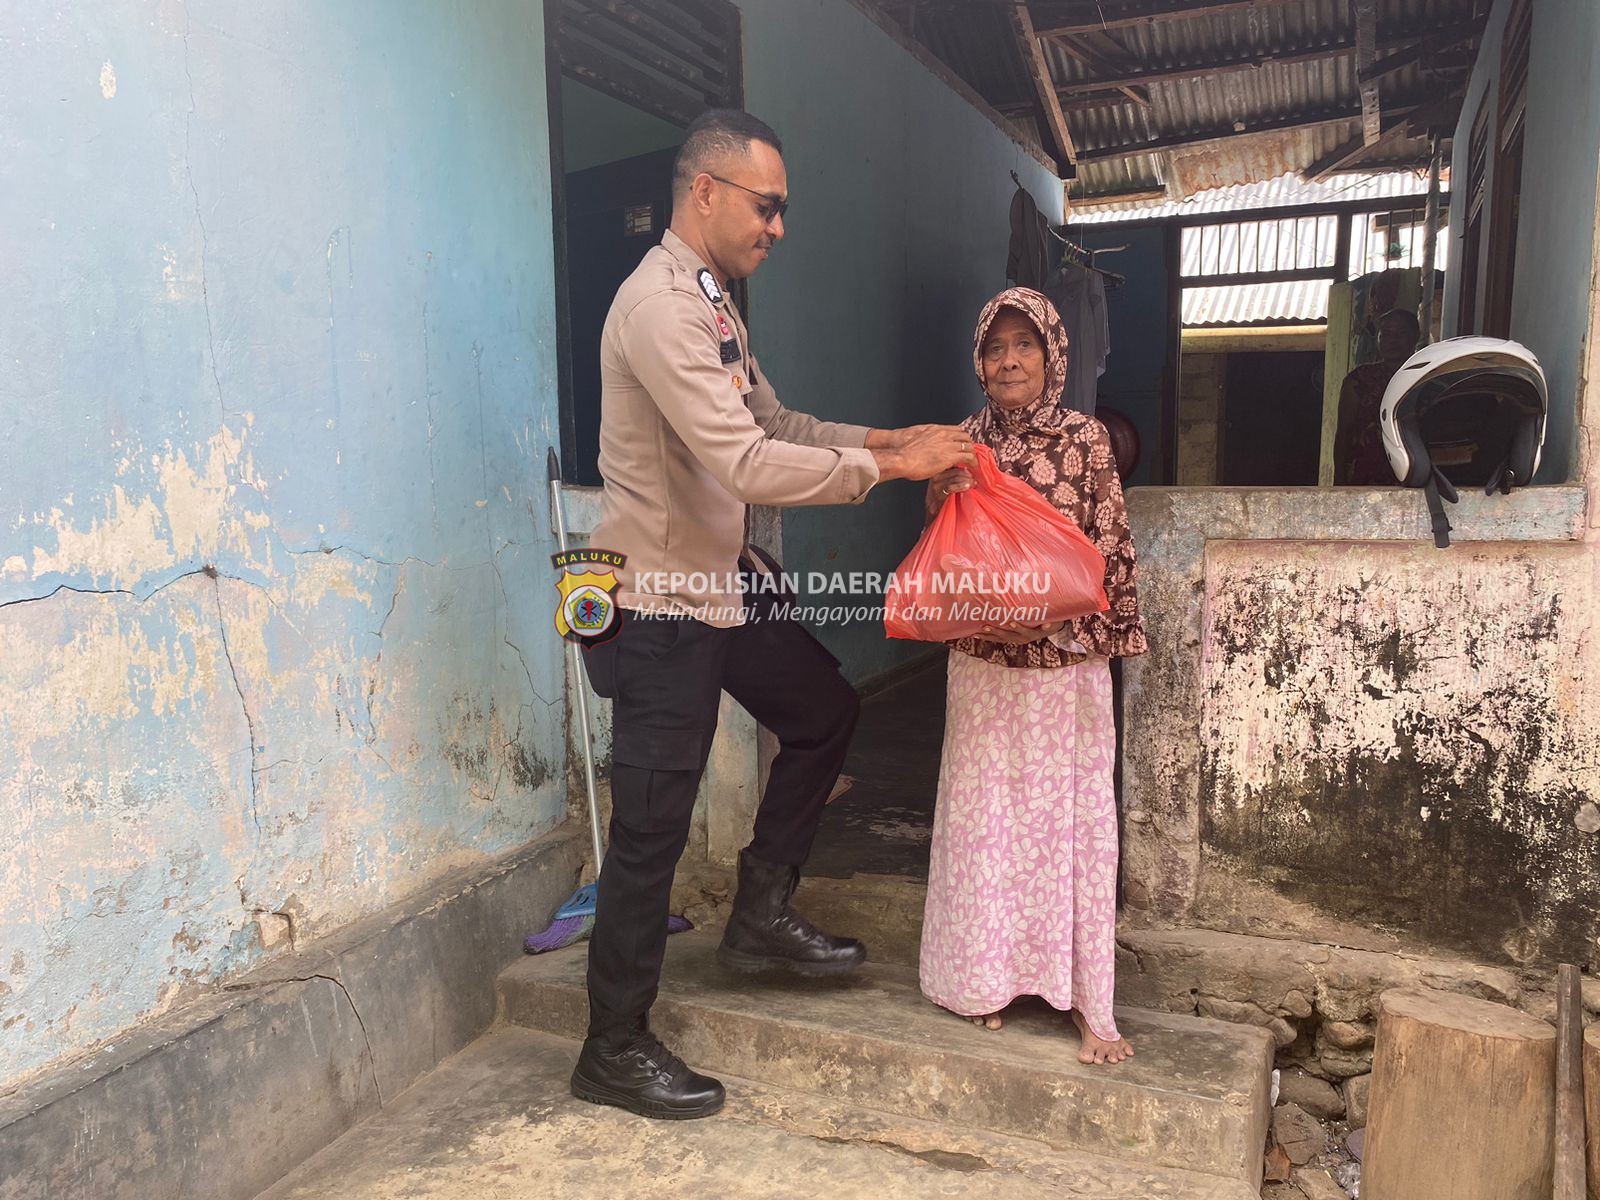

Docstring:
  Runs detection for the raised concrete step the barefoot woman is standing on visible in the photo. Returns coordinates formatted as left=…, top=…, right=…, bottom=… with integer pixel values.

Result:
left=499, top=931, right=1272, bottom=1186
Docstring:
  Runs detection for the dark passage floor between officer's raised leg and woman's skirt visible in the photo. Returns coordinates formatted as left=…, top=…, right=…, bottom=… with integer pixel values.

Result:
left=805, top=656, right=944, bottom=880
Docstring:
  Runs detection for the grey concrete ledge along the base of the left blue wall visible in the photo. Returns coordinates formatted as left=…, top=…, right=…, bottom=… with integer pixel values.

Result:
left=0, top=827, right=584, bottom=1200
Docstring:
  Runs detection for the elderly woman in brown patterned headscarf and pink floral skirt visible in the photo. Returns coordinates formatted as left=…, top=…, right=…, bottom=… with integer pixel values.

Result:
left=922, top=288, right=1146, bottom=1062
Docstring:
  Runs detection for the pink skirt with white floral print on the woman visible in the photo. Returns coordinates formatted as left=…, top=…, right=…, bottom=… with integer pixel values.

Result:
left=922, top=651, right=1118, bottom=1040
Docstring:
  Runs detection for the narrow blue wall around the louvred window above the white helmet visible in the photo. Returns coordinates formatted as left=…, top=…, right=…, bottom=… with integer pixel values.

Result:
left=1443, top=0, right=1600, bottom=483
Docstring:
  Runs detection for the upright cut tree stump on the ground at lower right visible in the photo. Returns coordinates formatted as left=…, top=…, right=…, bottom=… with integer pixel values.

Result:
left=1362, top=987, right=1555, bottom=1200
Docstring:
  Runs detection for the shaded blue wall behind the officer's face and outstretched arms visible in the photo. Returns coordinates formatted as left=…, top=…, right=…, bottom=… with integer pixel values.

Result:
left=739, top=0, right=1061, bottom=680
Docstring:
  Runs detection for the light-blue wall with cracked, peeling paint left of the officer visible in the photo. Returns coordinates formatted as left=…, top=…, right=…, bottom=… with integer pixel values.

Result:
left=0, top=0, right=565, bottom=1086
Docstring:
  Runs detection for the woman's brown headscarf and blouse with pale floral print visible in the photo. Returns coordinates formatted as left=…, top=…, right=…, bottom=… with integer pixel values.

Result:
left=950, top=288, right=1149, bottom=667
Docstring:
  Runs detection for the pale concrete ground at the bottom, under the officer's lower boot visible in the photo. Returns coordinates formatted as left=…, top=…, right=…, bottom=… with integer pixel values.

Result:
left=256, top=1026, right=1254, bottom=1200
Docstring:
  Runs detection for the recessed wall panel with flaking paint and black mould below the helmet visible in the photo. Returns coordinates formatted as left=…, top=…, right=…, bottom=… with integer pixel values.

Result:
left=1202, top=542, right=1600, bottom=963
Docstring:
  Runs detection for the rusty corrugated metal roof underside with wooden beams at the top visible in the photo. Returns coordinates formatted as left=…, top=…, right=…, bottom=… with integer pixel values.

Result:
left=890, top=0, right=1475, bottom=198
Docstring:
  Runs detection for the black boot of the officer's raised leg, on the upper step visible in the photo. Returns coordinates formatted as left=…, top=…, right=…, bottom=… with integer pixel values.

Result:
left=717, top=851, right=867, bottom=974
